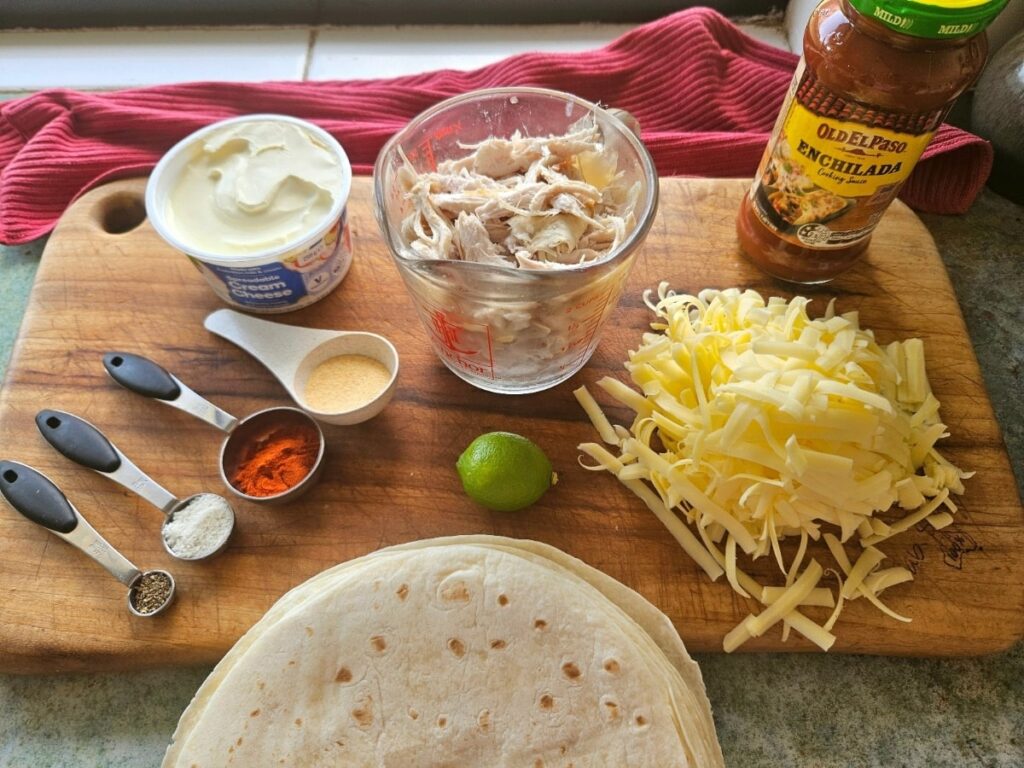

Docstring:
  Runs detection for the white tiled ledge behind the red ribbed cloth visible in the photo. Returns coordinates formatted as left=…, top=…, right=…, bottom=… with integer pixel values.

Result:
left=0, top=20, right=786, bottom=92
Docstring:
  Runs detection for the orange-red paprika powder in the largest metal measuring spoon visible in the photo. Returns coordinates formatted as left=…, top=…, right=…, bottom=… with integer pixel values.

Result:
left=231, top=424, right=319, bottom=497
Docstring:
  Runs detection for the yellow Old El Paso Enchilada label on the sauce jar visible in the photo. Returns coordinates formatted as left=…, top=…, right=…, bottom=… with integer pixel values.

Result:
left=751, top=60, right=946, bottom=249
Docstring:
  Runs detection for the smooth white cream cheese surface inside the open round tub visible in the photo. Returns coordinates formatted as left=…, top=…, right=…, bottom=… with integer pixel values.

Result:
left=165, top=120, right=343, bottom=255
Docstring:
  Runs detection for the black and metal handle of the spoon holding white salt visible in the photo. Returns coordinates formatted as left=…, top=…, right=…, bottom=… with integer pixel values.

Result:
left=36, top=409, right=178, bottom=514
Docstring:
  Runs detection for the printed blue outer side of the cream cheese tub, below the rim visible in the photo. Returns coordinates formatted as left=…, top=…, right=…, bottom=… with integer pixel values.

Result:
left=193, top=214, right=350, bottom=309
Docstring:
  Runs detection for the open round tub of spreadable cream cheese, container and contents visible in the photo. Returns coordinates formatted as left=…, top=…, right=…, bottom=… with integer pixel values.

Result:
left=145, top=115, right=352, bottom=312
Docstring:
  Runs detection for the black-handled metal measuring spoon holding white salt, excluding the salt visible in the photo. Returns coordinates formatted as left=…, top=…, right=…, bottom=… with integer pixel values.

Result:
left=36, top=409, right=234, bottom=560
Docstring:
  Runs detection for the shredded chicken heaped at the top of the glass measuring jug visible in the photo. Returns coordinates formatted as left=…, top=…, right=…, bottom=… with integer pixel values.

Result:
left=401, top=117, right=640, bottom=269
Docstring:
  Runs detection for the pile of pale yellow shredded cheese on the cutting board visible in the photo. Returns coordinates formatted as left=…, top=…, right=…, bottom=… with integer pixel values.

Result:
left=574, top=283, right=971, bottom=651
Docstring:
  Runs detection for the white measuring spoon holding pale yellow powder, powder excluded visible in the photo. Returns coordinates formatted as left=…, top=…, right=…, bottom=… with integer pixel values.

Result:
left=203, top=309, right=398, bottom=424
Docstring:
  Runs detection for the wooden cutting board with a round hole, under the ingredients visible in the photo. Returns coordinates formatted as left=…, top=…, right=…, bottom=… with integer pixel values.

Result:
left=0, top=178, right=1024, bottom=673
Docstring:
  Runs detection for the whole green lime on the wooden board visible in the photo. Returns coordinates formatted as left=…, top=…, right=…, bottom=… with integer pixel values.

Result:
left=455, top=432, right=554, bottom=512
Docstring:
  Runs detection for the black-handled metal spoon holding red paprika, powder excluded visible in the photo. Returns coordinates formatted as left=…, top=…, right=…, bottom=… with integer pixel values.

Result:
left=103, top=352, right=325, bottom=504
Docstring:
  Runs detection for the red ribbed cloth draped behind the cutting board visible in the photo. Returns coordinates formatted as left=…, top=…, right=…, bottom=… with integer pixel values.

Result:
left=0, top=8, right=992, bottom=244
